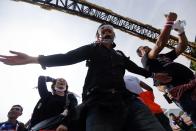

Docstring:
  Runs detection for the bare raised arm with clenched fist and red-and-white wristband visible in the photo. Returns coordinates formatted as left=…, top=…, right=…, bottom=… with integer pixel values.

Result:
left=148, top=12, right=177, bottom=59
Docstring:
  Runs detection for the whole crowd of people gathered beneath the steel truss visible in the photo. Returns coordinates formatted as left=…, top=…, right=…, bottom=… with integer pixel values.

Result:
left=0, top=12, right=196, bottom=131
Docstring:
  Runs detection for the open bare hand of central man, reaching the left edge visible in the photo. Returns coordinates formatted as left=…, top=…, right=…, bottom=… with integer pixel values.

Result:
left=0, top=51, right=38, bottom=65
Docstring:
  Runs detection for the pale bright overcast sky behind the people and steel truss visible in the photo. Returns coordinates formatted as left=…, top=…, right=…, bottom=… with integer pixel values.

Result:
left=0, top=0, right=196, bottom=123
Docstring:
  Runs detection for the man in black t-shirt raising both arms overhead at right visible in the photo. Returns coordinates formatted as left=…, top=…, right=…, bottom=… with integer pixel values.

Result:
left=137, top=13, right=196, bottom=126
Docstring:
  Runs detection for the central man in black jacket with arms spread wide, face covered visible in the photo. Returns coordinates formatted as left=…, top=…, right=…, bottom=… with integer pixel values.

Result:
left=0, top=24, right=169, bottom=131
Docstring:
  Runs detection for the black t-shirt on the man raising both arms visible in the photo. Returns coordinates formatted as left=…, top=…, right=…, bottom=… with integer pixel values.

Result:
left=142, top=50, right=194, bottom=86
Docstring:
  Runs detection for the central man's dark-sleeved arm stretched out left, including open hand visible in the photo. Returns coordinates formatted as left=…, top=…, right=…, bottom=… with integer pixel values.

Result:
left=0, top=44, right=93, bottom=68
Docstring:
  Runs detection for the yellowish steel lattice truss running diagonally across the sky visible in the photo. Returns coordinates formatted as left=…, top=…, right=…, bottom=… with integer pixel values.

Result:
left=14, top=0, right=196, bottom=61
